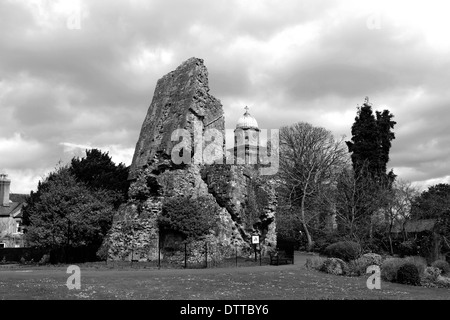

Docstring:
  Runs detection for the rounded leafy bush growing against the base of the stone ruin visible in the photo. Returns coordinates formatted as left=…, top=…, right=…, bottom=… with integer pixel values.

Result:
left=158, top=196, right=218, bottom=239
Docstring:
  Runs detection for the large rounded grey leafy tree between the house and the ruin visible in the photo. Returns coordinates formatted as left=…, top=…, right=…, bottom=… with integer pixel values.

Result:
left=24, top=167, right=114, bottom=249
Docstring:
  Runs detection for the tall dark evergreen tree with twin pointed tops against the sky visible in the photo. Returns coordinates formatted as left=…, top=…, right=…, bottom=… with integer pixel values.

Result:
left=346, top=97, right=396, bottom=184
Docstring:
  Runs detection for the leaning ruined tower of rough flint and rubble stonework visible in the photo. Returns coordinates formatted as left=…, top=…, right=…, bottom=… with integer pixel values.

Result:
left=107, top=58, right=277, bottom=262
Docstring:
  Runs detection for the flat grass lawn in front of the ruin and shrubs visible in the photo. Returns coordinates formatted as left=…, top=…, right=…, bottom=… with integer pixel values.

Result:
left=0, top=256, right=450, bottom=300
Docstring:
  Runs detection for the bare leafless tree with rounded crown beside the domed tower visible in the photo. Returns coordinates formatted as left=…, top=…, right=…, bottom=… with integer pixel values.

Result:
left=278, top=122, right=347, bottom=250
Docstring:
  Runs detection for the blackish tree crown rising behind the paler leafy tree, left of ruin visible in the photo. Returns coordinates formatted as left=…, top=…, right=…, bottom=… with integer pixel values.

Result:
left=69, top=149, right=130, bottom=207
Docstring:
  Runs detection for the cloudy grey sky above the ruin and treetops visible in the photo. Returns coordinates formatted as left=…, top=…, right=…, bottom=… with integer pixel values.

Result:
left=0, top=0, right=450, bottom=193
